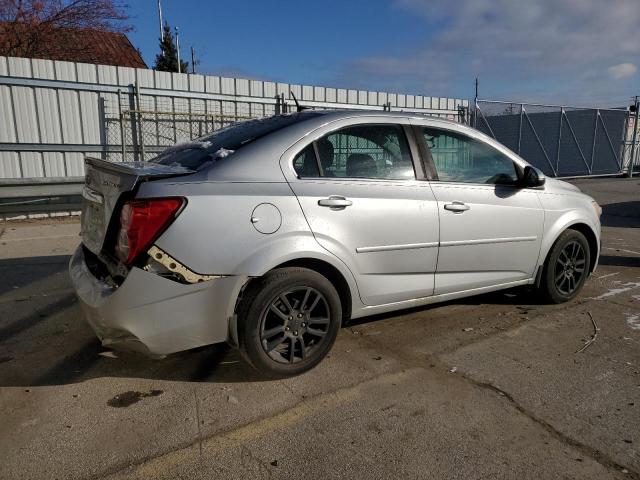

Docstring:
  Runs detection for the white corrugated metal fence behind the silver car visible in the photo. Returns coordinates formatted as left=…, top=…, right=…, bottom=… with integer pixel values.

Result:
left=0, top=57, right=468, bottom=180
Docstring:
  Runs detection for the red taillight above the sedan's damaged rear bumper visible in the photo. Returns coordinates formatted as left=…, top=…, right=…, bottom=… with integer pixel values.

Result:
left=116, top=198, right=184, bottom=264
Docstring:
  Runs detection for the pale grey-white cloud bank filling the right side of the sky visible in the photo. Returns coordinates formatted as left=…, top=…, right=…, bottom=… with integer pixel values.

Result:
left=343, top=0, right=640, bottom=104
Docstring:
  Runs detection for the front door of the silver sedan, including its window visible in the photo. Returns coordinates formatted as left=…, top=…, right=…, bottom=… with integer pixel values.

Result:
left=417, top=122, right=544, bottom=295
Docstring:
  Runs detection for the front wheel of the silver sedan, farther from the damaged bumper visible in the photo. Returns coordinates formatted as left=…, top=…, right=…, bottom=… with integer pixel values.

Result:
left=540, top=230, right=591, bottom=303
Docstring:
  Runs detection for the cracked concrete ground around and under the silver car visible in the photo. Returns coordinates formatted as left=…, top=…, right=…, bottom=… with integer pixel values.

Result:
left=0, top=179, right=640, bottom=479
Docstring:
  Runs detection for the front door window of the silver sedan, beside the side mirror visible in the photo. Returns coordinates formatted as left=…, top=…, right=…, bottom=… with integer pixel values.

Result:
left=423, top=128, right=518, bottom=185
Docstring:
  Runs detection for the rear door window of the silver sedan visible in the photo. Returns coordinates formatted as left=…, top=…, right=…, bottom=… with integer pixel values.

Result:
left=316, top=124, right=415, bottom=180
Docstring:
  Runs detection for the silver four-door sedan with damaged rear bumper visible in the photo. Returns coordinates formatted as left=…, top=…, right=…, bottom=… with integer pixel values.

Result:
left=70, top=111, right=601, bottom=376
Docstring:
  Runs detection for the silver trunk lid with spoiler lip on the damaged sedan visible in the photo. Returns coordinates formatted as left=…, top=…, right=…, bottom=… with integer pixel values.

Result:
left=80, top=157, right=195, bottom=255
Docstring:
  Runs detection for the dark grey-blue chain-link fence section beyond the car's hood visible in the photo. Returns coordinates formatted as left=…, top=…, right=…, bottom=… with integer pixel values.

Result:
left=470, top=100, right=632, bottom=177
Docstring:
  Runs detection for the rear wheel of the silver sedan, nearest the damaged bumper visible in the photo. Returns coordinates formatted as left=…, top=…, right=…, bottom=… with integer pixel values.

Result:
left=238, top=267, right=342, bottom=377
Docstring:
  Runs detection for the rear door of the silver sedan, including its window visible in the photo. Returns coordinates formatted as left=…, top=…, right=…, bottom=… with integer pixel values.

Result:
left=285, top=117, right=439, bottom=305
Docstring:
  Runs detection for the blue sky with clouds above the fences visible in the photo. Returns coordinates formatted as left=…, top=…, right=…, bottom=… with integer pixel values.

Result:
left=128, top=0, right=640, bottom=106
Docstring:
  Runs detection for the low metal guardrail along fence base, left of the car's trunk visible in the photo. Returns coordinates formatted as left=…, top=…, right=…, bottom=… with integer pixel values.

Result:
left=0, top=177, right=84, bottom=217
